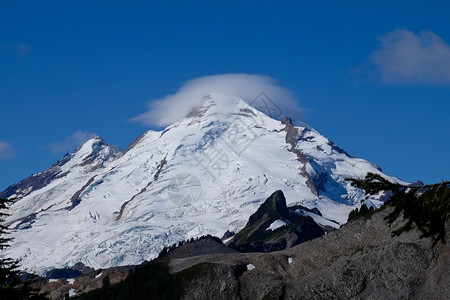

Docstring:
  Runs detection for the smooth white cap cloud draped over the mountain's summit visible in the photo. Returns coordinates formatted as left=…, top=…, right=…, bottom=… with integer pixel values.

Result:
left=132, top=74, right=300, bottom=126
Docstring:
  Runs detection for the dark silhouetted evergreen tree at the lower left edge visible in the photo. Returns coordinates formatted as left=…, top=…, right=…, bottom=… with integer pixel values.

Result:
left=0, top=199, right=46, bottom=300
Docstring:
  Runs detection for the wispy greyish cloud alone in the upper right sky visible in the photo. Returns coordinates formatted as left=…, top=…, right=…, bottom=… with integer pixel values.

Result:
left=370, top=29, right=450, bottom=84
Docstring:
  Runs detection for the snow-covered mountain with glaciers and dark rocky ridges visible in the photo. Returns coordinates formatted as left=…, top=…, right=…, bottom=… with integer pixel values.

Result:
left=0, top=94, right=404, bottom=273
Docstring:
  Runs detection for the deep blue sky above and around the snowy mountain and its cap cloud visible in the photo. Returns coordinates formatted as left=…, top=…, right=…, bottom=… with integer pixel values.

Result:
left=0, top=1, right=450, bottom=190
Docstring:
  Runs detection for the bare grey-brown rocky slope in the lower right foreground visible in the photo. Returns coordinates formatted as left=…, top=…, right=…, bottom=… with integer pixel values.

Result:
left=170, top=208, right=450, bottom=299
